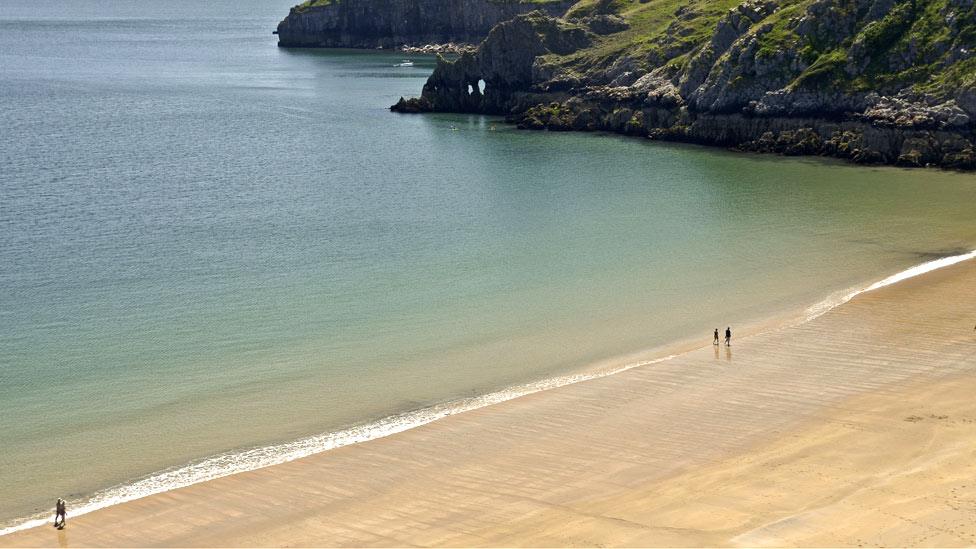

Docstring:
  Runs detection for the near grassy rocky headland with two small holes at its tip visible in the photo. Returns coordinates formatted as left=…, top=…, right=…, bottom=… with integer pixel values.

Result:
left=393, top=0, right=976, bottom=169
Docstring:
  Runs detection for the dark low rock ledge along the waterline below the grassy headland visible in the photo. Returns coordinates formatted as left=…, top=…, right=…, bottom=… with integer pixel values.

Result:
left=509, top=88, right=976, bottom=170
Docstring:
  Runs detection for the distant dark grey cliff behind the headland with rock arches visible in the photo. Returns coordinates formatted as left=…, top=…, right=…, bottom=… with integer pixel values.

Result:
left=277, top=0, right=572, bottom=48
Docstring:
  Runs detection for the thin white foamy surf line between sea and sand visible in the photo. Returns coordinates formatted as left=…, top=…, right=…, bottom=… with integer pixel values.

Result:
left=0, top=252, right=976, bottom=544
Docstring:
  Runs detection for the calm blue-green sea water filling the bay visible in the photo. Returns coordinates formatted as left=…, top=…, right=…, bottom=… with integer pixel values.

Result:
left=0, top=0, right=976, bottom=526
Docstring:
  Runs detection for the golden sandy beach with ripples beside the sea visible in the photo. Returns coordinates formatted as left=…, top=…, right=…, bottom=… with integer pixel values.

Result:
left=7, top=261, right=976, bottom=547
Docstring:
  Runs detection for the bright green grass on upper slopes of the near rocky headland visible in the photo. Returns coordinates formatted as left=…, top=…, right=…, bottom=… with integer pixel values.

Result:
left=543, top=0, right=976, bottom=99
